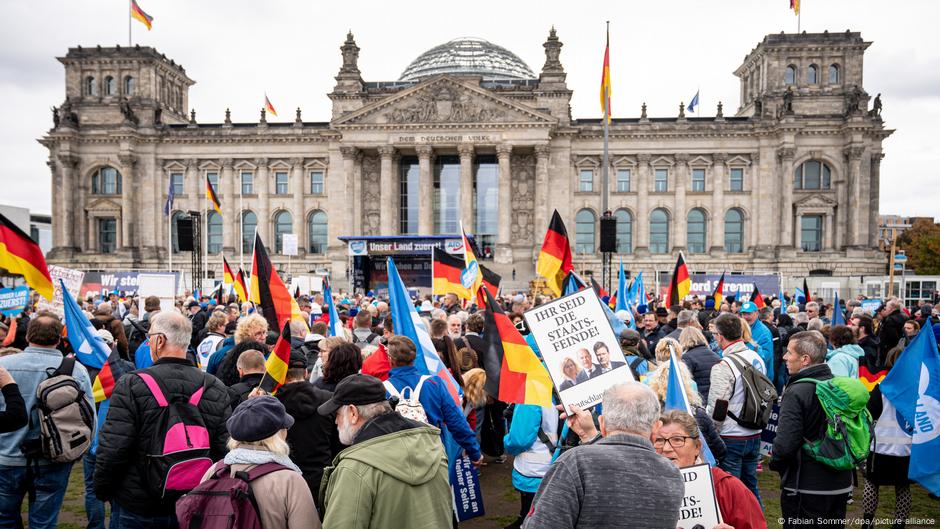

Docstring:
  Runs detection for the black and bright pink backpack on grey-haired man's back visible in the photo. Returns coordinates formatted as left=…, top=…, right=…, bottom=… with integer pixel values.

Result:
left=137, top=372, right=212, bottom=499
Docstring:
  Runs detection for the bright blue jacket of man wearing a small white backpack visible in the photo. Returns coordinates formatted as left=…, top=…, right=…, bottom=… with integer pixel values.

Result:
left=388, top=366, right=480, bottom=461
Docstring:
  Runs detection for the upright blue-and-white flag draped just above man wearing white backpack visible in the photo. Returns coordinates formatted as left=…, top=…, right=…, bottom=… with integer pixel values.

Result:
left=388, top=257, right=463, bottom=407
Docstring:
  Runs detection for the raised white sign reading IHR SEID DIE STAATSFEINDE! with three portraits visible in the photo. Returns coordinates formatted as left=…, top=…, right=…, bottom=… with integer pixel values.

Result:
left=524, top=288, right=633, bottom=410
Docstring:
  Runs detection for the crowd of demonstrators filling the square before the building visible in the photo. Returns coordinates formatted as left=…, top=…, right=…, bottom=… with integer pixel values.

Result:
left=0, top=284, right=940, bottom=529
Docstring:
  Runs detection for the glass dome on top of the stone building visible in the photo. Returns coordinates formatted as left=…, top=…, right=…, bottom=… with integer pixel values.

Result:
left=399, top=37, right=536, bottom=81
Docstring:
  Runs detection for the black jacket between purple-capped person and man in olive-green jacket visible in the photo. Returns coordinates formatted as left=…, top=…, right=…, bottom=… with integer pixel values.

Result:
left=277, top=381, right=342, bottom=507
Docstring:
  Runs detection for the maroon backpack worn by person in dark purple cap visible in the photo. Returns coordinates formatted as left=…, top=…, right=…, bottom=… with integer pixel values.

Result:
left=176, top=463, right=287, bottom=529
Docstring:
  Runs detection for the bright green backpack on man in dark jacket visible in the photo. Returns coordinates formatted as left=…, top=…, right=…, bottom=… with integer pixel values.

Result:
left=798, top=377, right=872, bottom=470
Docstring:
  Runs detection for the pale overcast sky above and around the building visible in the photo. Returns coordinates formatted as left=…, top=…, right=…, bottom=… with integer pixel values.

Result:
left=0, top=0, right=940, bottom=217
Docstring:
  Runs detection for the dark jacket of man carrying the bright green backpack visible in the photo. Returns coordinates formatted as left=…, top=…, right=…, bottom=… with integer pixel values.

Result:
left=770, top=364, right=852, bottom=494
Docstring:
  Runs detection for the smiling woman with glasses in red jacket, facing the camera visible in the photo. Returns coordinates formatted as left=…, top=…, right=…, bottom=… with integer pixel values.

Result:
left=651, top=410, right=767, bottom=529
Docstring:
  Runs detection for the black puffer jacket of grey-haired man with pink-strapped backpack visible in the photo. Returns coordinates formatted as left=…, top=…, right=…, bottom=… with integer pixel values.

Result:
left=94, top=358, right=232, bottom=516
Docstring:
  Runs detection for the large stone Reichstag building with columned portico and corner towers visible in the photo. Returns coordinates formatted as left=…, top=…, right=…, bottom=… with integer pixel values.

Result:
left=39, top=29, right=892, bottom=284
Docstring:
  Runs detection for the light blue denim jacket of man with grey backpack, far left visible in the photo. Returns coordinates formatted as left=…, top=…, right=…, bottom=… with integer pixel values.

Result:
left=0, top=347, right=97, bottom=467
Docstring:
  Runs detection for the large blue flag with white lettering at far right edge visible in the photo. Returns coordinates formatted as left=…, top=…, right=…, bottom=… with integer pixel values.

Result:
left=881, top=325, right=940, bottom=495
